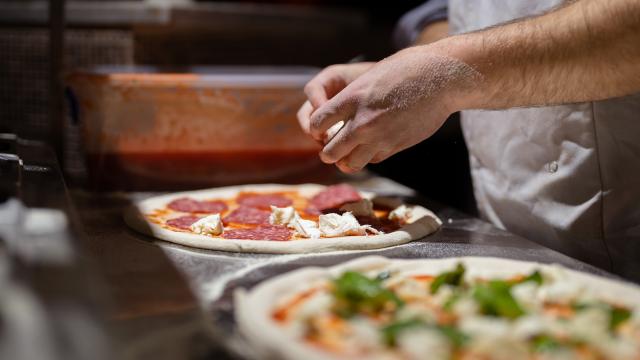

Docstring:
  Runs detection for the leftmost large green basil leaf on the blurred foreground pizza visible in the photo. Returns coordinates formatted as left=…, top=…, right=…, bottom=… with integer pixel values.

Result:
left=333, top=271, right=404, bottom=317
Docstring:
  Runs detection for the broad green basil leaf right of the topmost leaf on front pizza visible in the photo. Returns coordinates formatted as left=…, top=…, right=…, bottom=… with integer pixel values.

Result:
left=473, top=280, right=525, bottom=319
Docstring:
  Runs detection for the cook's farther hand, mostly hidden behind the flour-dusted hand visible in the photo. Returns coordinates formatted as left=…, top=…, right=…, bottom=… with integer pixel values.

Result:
left=298, top=62, right=375, bottom=140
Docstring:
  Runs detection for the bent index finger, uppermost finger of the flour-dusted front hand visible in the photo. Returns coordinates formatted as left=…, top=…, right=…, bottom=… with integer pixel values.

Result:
left=309, top=93, right=356, bottom=141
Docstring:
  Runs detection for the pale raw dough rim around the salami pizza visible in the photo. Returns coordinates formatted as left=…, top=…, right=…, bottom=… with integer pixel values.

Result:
left=124, top=184, right=442, bottom=254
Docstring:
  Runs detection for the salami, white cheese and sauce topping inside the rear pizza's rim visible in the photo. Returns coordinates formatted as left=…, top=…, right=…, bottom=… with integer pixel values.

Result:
left=147, top=184, right=407, bottom=240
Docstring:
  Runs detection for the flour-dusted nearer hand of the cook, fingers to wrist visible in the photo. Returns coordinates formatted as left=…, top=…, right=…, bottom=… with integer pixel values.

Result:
left=303, top=46, right=481, bottom=172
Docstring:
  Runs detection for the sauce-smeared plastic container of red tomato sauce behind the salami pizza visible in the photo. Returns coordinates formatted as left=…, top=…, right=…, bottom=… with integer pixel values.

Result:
left=67, top=67, right=334, bottom=190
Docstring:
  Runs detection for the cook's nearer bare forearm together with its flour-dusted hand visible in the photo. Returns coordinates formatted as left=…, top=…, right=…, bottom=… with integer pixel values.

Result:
left=300, top=0, right=640, bottom=172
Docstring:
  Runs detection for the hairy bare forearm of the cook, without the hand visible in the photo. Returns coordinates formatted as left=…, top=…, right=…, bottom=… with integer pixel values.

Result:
left=425, top=0, right=640, bottom=110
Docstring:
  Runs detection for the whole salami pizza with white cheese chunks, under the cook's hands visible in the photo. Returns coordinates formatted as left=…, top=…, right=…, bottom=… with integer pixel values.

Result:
left=125, top=184, right=441, bottom=253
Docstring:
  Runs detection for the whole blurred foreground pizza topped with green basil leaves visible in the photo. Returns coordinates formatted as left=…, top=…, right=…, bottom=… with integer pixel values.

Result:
left=235, top=257, right=640, bottom=360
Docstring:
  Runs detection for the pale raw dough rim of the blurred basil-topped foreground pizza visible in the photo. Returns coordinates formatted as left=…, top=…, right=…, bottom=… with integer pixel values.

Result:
left=234, top=256, right=640, bottom=360
